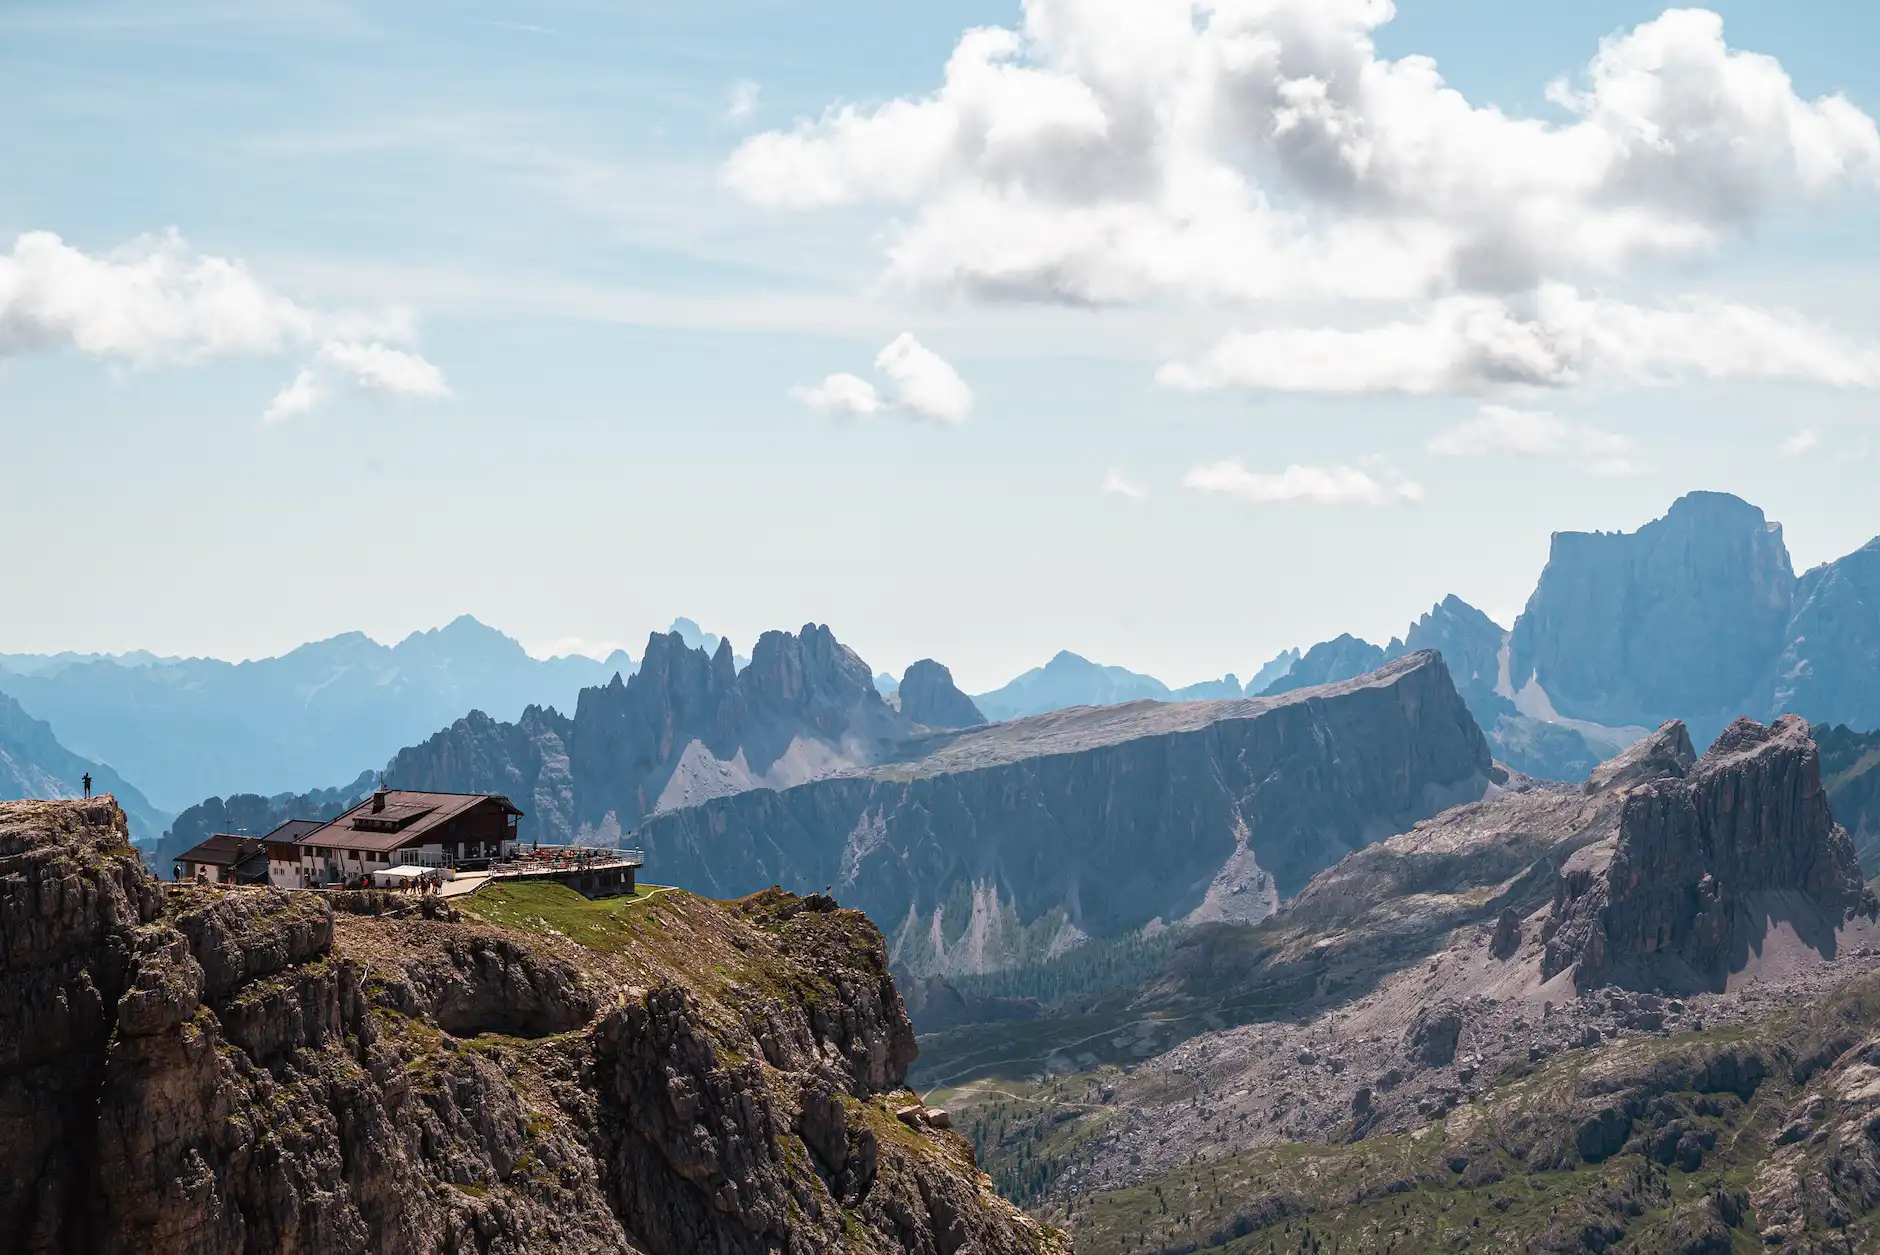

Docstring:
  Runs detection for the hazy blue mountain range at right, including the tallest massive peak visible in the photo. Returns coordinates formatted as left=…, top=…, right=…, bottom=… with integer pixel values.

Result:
left=1225, top=492, right=1880, bottom=782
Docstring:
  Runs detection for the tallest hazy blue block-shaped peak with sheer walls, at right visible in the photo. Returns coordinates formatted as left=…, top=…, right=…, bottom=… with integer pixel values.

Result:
left=1510, top=492, right=1795, bottom=742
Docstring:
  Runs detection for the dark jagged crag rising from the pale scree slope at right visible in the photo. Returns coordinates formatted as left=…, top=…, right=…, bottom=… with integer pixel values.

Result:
left=1542, top=716, right=1876, bottom=990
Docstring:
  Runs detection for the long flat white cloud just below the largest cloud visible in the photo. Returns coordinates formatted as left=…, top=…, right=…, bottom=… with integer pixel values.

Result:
left=1158, top=284, right=1880, bottom=395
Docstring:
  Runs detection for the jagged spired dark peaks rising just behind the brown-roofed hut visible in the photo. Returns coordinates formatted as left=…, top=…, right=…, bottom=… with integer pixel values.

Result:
left=385, top=624, right=912, bottom=842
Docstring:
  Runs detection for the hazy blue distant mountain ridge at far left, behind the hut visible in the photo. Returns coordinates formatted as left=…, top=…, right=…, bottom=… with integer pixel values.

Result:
left=0, top=616, right=632, bottom=810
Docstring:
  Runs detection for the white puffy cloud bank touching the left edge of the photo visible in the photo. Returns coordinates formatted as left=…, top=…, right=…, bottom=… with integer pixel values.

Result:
left=0, top=231, right=449, bottom=421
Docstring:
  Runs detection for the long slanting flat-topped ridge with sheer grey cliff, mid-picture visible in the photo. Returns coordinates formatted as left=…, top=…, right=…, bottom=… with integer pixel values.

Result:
left=637, top=654, right=1495, bottom=975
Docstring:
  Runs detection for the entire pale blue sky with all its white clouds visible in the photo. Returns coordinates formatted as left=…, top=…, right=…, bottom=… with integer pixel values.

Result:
left=0, top=0, right=1880, bottom=691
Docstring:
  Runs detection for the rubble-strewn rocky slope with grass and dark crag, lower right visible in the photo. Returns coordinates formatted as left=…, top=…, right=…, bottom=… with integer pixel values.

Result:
left=919, top=720, right=1880, bottom=1255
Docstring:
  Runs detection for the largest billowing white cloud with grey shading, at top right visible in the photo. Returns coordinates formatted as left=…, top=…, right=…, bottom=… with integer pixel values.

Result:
left=724, top=0, right=1880, bottom=302
